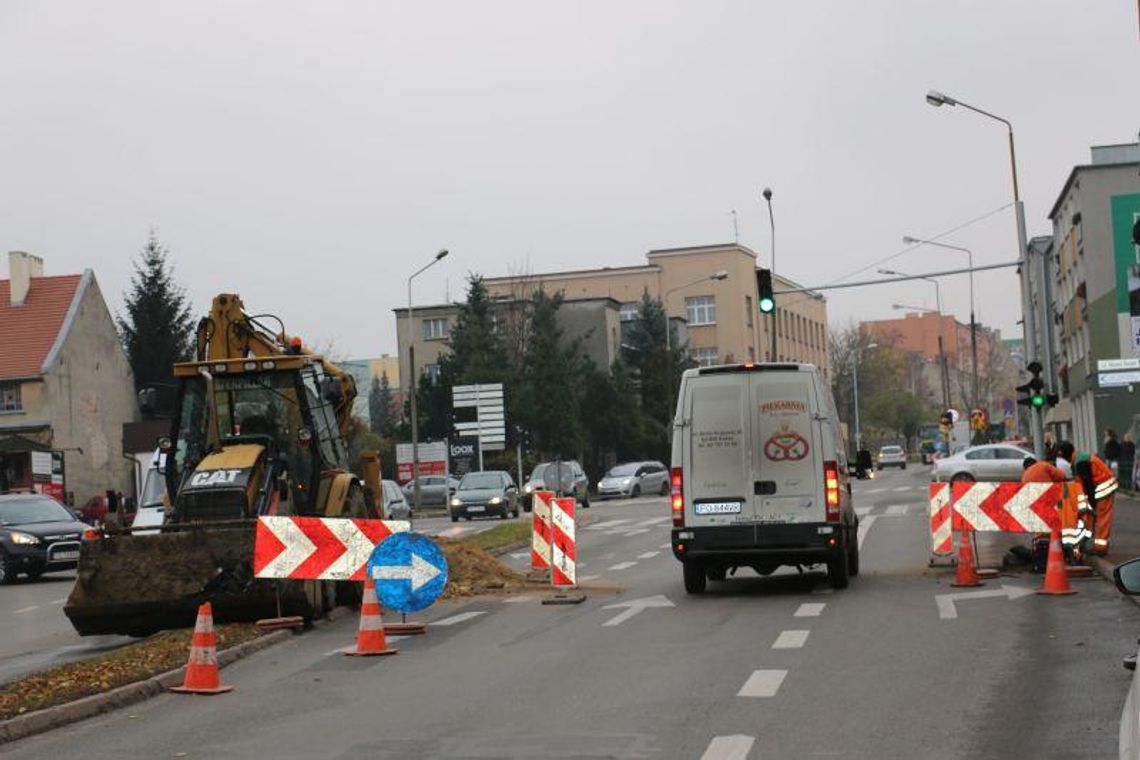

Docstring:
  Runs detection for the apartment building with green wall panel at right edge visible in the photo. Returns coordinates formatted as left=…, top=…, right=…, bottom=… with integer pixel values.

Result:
left=1044, top=144, right=1140, bottom=450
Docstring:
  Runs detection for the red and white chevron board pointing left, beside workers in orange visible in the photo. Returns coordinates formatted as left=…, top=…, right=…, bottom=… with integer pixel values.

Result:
left=931, top=483, right=1061, bottom=533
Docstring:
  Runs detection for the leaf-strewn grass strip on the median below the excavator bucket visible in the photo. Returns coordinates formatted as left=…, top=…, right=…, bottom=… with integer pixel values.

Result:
left=0, top=623, right=260, bottom=720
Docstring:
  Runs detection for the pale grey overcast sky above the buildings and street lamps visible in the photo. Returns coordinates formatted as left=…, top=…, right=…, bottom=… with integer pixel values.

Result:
left=0, top=0, right=1140, bottom=357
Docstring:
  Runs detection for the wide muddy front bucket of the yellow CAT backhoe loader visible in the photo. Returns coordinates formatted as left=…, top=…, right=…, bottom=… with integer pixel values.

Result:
left=64, top=521, right=323, bottom=636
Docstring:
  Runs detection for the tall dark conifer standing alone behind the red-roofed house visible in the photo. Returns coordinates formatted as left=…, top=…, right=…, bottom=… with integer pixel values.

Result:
left=119, top=232, right=194, bottom=389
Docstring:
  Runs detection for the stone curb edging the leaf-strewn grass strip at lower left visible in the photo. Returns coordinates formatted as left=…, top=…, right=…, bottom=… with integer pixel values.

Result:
left=0, top=628, right=296, bottom=745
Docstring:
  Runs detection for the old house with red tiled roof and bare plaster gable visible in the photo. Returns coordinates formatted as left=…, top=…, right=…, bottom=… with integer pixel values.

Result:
left=0, top=252, right=139, bottom=504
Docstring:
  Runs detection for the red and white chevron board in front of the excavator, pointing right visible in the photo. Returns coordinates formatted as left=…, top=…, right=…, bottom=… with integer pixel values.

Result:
left=253, top=516, right=412, bottom=581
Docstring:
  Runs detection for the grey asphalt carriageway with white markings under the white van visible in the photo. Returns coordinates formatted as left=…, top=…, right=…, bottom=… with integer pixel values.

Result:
left=5, top=468, right=1140, bottom=760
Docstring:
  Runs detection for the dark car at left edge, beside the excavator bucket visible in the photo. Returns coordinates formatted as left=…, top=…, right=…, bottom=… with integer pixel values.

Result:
left=0, top=493, right=88, bottom=583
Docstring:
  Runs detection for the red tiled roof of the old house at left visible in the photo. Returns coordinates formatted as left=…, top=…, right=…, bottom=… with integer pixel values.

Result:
left=0, top=275, right=81, bottom=378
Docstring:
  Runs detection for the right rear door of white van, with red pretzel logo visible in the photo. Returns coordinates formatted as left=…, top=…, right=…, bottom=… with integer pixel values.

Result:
left=749, top=369, right=827, bottom=523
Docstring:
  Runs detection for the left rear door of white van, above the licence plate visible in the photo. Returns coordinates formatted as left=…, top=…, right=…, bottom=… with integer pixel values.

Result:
left=683, top=373, right=755, bottom=530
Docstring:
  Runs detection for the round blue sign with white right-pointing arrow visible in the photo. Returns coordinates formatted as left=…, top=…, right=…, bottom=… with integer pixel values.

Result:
left=368, top=532, right=447, bottom=612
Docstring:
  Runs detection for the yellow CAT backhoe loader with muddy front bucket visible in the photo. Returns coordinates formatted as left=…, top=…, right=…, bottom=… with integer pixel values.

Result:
left=64, top=294, right=381, bottom=636
